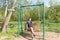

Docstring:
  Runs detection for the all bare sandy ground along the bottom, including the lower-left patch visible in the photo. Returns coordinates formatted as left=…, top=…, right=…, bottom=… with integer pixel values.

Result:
left=0, top=32, right=60, bottom=40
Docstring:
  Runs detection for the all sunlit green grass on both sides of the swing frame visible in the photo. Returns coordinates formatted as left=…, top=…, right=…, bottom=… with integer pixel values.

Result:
left=0, top=22, right=60, bottom=40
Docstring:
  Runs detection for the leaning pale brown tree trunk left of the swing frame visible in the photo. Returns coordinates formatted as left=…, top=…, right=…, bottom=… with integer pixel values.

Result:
left=2, top=0, right=17, bottom=32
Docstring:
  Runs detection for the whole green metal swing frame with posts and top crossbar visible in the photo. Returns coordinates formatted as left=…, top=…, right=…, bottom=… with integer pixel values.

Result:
left=18, top=3, right=45, bottom=40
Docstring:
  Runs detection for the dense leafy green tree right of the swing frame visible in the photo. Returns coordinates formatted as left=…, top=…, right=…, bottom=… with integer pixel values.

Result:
left=46, top=5, right=60, bottom=23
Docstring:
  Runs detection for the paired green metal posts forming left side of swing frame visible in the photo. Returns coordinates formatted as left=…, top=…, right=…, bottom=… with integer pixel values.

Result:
left=18, top=5, right=23, bottom=36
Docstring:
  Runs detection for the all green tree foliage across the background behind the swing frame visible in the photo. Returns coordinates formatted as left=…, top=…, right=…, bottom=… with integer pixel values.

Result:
left=0, top=0, right=60, bottom=22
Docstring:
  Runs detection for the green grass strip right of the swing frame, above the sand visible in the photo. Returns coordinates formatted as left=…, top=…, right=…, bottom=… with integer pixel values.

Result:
left=45, top=23, right=60, bottom=33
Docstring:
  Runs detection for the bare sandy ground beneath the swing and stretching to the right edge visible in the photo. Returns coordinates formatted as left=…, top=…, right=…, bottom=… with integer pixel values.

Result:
left=14, top=32, right=60, bottom=40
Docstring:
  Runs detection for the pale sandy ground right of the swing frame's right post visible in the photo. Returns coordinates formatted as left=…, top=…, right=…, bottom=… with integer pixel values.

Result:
left=46, top=32, right=60, bottom=40
